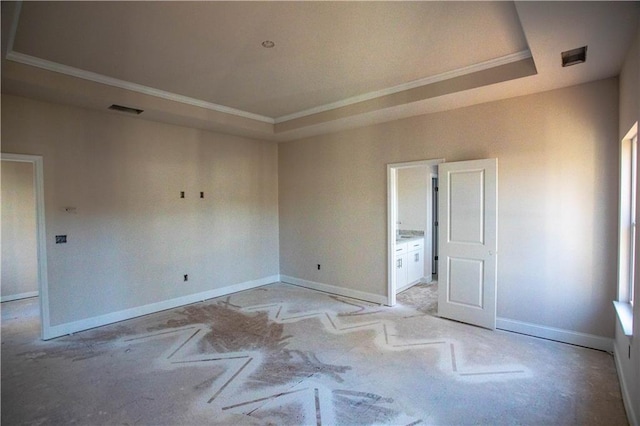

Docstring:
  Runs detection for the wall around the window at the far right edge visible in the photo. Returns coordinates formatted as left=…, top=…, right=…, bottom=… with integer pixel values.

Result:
left=615, top=21, right=640, bottom=425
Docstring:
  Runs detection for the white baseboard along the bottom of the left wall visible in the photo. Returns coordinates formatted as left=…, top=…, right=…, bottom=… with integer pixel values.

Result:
left=43, top=275, right=280, bottom=340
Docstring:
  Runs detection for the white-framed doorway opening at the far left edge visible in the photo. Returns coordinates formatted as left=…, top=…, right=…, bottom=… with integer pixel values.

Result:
left=1, top=153, right=50, bottom=339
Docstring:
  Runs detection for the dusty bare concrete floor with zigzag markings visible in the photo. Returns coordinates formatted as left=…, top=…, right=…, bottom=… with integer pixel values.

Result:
left=1, top=283, right=627, bottom=425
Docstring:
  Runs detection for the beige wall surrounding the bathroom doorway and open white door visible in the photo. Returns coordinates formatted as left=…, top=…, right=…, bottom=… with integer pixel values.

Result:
left=278, top=78, right=618, bottom=339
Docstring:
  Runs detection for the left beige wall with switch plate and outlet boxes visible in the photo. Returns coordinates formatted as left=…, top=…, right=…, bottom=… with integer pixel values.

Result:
left=2, top=95, right=278, bottom=326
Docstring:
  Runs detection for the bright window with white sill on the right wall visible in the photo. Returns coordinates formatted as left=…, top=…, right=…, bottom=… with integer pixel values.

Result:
left=614, top=123, right=638, bottom=336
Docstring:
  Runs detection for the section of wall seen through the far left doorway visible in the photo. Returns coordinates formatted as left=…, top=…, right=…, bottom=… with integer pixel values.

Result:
left=0, top=160, right=38, bottom=301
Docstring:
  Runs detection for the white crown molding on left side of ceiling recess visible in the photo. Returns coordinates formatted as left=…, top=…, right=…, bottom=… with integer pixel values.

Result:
left=7, top=51, right=274, bottom=124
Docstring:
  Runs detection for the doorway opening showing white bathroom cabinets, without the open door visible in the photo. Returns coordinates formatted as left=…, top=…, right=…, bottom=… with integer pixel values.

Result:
left=387, top=159, right=444, bottom=306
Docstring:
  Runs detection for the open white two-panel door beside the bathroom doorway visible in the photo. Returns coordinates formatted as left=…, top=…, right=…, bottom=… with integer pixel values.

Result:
left=438, top=158, right=498, bottom=330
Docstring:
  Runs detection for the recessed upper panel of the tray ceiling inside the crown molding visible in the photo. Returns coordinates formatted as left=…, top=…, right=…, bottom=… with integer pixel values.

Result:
left=13, top=2, right=527, bottom=118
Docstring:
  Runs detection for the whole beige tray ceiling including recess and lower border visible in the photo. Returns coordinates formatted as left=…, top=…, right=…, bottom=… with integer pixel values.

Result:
left=2, top=1, right=638, bottom=138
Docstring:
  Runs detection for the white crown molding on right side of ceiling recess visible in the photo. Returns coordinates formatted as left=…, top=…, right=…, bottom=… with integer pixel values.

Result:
left=275, top=49, right=532, bottom=124
